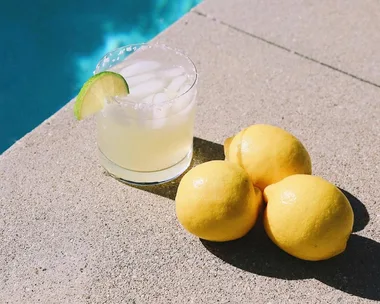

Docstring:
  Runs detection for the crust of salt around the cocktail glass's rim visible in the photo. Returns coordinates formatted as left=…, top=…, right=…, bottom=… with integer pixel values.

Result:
left=93, top=43, right=198, bottom=109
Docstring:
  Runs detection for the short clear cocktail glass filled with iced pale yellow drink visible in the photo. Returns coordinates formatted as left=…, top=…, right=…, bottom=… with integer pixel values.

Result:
left=94, top=44, right=197, bottom=184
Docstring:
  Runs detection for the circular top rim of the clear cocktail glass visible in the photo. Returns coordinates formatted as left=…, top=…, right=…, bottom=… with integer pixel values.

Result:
left=93, top=42, right=198, bottom=106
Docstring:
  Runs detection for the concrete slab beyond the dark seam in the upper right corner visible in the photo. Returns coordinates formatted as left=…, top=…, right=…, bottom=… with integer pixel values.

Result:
left=195, top=0, right=380, bottom=86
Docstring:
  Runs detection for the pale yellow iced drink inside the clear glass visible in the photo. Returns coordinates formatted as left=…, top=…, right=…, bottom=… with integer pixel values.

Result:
left=97, top=58, right=196, bottom=176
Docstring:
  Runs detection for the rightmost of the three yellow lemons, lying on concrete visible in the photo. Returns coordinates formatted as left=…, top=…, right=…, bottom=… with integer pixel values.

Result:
left=264, top=174, right=354, bottom=261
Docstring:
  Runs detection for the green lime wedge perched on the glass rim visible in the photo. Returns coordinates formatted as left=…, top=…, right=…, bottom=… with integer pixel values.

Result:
left=74, top=71, right=129, bottom=120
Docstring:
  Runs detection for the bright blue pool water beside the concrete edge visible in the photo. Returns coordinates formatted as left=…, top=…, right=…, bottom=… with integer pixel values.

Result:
left=0, top=0, right=201, bottom=153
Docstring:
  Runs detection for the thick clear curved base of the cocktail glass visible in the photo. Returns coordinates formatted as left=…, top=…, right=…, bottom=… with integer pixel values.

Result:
left=98, top=149, right=193, bottom=186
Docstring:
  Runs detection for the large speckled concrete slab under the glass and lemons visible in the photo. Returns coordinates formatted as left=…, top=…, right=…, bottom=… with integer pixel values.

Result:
left=0, top=1, right=380, bottom=303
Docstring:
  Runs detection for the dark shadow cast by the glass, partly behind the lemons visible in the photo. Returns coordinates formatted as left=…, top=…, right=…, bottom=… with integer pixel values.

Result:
left=132, top=137, right=224, bottom=200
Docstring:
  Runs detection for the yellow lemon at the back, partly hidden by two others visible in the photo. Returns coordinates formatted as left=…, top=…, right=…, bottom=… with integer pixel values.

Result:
left=224, top=125, right=311, bottom=190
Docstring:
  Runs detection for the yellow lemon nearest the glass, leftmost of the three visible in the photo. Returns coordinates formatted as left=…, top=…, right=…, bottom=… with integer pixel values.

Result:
left=176, top=160, right=262, bottom=242
